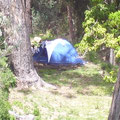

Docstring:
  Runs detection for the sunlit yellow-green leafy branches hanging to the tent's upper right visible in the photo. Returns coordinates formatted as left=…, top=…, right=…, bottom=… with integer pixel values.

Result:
left=80, top=3, right=115, bottom=50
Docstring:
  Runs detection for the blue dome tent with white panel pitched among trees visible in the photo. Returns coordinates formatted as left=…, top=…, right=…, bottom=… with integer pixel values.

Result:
left=33, top=39, right=85, bottom=65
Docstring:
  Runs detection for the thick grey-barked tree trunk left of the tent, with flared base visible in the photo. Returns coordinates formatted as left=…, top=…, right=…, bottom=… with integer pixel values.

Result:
left=0, top=0, right=54, bottom=88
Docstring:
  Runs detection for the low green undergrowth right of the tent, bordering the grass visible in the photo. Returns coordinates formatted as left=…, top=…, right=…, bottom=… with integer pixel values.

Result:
left=86, top=51, right=118, bottom=83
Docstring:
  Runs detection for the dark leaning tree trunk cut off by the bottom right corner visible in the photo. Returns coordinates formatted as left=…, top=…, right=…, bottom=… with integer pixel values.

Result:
left=108, top=64, right=120, bottom=120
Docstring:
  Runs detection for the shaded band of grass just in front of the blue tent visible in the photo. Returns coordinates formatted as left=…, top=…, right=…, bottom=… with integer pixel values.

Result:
left=37, top=65, right=113, bottom=96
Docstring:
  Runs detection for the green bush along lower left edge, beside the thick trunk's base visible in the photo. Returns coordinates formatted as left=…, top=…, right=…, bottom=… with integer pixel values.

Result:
left=0, top=57, right=16, bottom=120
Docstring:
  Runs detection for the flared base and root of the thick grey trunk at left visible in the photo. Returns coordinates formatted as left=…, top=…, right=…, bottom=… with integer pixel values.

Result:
left=17, top=69, right=57, bottom=90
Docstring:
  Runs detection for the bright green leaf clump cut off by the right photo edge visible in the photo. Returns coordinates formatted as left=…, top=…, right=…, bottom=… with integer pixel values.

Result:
left=107, top=11, right=120, bottom=58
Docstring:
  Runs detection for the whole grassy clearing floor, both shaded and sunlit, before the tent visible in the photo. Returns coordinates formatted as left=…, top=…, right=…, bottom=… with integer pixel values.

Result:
left=9, top=64, right=113, bottom=120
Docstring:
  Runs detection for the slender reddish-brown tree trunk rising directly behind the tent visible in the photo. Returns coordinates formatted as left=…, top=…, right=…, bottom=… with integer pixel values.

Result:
left=67, top=5, right=74, bottom=43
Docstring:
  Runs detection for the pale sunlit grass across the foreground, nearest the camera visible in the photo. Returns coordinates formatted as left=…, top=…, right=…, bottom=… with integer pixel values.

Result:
left=10, top=90, right=111, bottom=120
